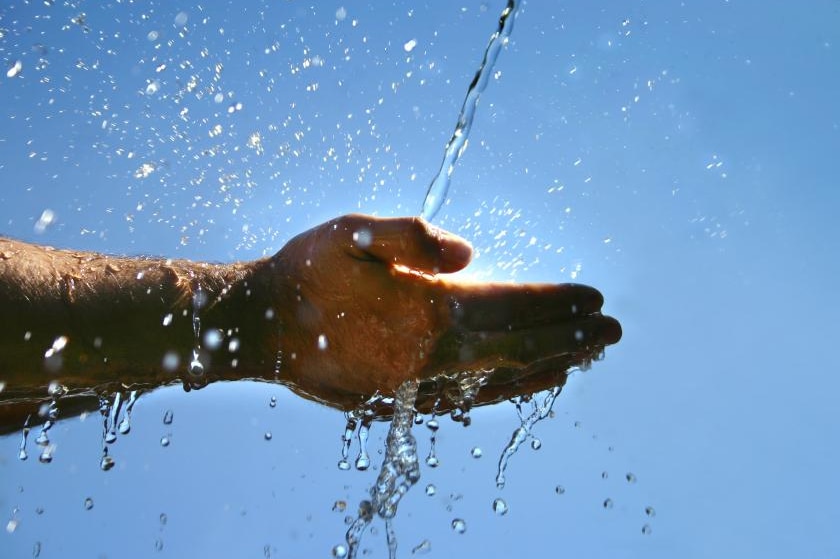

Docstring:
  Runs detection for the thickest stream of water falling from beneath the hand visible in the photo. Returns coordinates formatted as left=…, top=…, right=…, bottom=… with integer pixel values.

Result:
left=346, top=380, right=420, bottom=559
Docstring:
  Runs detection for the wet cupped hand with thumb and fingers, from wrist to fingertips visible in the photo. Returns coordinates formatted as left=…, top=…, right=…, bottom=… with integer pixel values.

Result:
left=256, top=215, right=621, bottom=404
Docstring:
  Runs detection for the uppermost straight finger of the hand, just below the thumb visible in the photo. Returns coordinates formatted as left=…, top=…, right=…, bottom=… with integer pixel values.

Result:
left=447, top=283, right=604, bottom=331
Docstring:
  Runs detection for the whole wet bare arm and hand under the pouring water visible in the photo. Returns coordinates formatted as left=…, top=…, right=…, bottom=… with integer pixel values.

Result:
left=0, top=215, right=621, bottom=432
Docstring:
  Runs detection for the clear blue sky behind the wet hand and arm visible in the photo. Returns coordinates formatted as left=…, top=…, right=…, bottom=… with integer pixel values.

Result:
left=0, top=0, right=840, bottom=558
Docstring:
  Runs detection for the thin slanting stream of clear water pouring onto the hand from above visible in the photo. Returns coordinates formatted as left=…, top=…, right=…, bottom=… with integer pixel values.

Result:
left=420, top=0, right=518, bottom=221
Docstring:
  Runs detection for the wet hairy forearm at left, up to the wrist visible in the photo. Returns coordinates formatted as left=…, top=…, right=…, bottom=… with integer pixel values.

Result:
left=0, top=239, right=278, bottom=399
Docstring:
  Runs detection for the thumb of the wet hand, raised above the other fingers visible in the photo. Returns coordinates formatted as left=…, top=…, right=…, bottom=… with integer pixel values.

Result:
left=332, top=214, right=472, bottom=274
